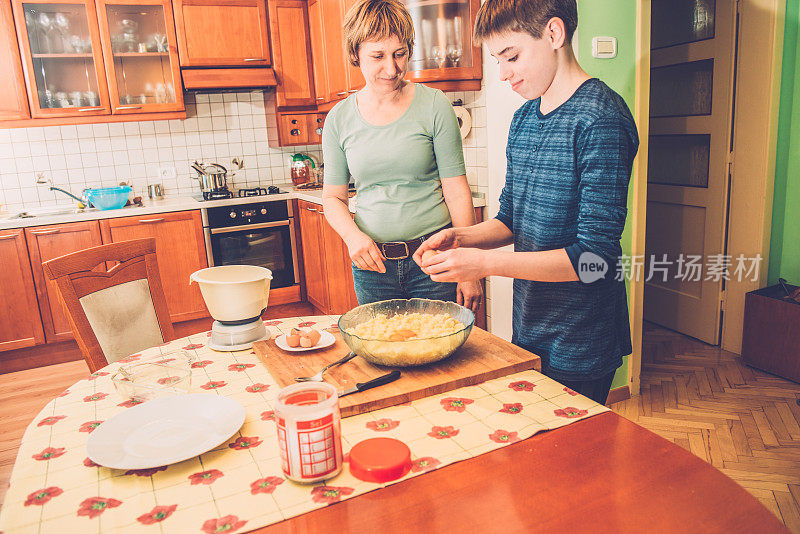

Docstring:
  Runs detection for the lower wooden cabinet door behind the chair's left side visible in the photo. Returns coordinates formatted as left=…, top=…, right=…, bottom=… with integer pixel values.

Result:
left=25, top=221, right=103, bottom=343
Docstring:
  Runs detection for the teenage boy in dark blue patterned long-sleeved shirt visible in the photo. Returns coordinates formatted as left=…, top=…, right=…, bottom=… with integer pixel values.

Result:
left=414, top=0, right=639, bottom=404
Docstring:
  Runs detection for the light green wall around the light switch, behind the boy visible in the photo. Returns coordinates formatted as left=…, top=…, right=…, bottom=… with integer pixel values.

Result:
left=578, top=0, right=636, bottom=394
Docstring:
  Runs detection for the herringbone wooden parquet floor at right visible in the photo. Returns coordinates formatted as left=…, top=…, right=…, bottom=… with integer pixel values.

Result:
left=610, top=323, right=800, bottom=533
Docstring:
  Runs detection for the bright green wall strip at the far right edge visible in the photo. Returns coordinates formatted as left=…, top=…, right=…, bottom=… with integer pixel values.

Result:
left=769, top=0, right=800, bottom=284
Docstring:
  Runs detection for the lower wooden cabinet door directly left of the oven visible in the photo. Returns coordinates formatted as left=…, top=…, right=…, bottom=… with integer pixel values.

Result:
left=100, top=210, right=208, bottom=322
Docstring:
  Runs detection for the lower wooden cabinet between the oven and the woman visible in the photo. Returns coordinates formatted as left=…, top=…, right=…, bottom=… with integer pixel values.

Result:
left=297, top=200, right=358, bottom=314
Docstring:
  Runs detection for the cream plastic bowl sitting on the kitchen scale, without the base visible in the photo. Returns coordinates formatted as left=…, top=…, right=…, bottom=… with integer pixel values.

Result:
left=189, top=265, right=272, bottom=325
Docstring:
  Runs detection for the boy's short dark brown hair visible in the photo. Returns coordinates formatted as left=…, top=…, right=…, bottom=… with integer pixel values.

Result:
left=473, top=0, right=578, bottom=43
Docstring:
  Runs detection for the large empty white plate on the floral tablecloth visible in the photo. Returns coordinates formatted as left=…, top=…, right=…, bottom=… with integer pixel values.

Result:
left=86, top=393, right=245, bottom=469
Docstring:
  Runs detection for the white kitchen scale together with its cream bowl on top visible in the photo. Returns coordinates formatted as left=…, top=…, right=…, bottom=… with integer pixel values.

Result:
left=189, top=265, right=272, bottom=351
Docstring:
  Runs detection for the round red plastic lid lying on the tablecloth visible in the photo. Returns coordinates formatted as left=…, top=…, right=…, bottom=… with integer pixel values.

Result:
left=350, top=438, right=411, bottom=482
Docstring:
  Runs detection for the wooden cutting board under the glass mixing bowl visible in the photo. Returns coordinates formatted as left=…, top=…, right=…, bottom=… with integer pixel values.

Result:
left=253, top=327, right=542, bottom=417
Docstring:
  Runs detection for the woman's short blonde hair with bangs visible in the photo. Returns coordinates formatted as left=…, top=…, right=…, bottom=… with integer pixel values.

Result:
left=344, top=0, right=414, bottom=67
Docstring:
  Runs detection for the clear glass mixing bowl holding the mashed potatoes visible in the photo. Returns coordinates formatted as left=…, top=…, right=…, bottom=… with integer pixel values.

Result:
left=339, top=299, right=475, bottom=367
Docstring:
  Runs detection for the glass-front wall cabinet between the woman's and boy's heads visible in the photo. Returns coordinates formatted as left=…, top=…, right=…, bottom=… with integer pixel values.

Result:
left=404, top=0, right=482, bottom=85
